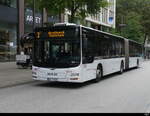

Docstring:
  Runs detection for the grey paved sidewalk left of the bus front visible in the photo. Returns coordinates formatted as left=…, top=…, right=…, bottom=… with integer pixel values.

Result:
left=0, top=62, right=34, bottom=88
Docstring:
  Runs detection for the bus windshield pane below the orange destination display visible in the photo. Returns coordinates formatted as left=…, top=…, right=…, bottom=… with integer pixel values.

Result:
left=34, top=40, right=81, bottom=68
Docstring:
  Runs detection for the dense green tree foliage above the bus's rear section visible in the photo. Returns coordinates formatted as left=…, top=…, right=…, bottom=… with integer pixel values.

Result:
left=113, top=0, right=150, bottom=43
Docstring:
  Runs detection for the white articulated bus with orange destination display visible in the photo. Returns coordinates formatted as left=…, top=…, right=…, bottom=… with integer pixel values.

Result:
left=29, top=24, right=142, bottom=83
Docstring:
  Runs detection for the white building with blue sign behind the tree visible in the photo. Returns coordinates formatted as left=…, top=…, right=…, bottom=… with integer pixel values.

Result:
left=64, top=0, right=116, bottom=31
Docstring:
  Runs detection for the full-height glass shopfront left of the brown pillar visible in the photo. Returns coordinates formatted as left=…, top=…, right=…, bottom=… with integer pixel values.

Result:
left=0, top=0, right=18, bottom=62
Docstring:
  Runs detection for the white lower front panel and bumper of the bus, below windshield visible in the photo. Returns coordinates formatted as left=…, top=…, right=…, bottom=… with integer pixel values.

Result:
left=32, top=66, right=84, bottom=83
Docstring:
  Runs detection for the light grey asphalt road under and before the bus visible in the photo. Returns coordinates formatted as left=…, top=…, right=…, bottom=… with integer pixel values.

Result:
left=0, top=61, right=150, bottom=113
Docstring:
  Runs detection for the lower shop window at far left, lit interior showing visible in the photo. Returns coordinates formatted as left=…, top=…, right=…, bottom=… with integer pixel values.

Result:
left=0, top=23, right=17, bottom=62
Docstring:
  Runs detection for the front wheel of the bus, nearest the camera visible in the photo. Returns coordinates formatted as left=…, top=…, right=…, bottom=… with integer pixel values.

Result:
left=94, top=65, right=103, bottom=83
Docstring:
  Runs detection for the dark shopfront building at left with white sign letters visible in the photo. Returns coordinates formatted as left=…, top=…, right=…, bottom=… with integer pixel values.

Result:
left=0, top=0, right=42, bottom=62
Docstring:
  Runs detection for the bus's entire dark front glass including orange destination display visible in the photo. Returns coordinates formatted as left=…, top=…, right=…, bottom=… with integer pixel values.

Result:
left=33, top=29, right=81, bottom=68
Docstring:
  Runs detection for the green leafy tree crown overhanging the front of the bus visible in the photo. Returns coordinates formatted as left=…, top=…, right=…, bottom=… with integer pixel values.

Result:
left=41, top=0, right=108, bottom=22
